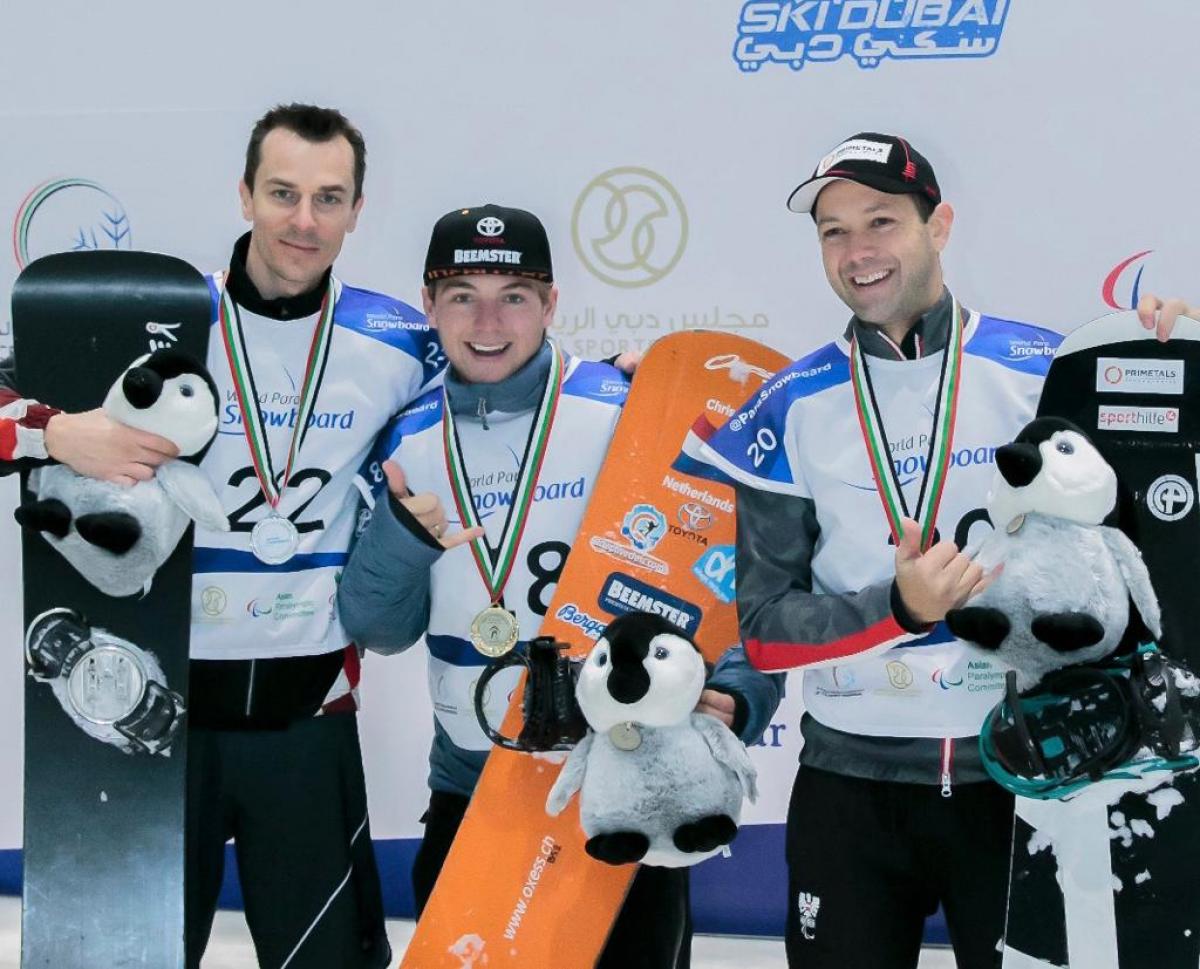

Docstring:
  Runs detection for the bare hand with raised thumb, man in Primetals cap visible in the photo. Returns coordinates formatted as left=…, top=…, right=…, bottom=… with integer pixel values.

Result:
left=896, top=518, right=992, bottom=624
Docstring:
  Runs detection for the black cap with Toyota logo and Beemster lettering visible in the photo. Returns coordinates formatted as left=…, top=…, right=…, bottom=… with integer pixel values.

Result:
left=425, top=204, right=554, bottom=283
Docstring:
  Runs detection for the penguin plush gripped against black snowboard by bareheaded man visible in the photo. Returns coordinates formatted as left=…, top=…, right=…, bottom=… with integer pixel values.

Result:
left=16, top=350, right=229, bottom=596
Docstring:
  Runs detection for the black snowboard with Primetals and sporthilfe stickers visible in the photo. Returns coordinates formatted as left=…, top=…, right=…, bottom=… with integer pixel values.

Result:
left=1004, top=313, right=1200, bottom=969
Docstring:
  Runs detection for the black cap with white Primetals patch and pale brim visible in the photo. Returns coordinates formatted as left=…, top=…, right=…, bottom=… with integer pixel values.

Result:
left=787, top=131, right=942, bottom=213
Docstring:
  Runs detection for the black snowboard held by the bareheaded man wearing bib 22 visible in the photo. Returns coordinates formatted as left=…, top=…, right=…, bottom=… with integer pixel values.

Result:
left=12, top=252, right=211, bottom=969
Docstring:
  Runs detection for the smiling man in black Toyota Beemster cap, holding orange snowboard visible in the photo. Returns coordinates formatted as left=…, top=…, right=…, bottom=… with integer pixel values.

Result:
left=338, top=205, right=757, bottom=969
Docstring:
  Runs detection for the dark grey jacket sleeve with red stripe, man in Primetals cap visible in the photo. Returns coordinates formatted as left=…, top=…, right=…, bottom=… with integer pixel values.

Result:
left=736, top=485, right=929, bottom=672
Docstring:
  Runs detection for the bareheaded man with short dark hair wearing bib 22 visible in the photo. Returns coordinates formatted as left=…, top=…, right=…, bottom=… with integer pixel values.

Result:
left=0, top=104, right=443, bottom=969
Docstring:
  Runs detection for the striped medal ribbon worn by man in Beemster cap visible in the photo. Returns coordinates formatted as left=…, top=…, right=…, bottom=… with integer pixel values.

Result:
left=442, top=343, right=563, bottom=604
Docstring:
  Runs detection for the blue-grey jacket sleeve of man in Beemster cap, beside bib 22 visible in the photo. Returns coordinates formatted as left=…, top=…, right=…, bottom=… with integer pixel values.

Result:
left=337, top=492, right=443, bottom=654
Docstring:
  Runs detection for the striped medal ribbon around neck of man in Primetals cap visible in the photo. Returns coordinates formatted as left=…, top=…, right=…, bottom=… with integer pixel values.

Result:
left=850, top=302, right=962, bottom=552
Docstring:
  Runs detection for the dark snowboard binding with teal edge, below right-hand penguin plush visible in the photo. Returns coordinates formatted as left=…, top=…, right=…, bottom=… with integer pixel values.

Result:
left=979, top=644, right=1200, bottom=800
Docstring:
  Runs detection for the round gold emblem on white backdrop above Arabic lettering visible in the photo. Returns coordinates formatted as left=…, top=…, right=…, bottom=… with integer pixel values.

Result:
left=571, top=168, right=688, bottom=288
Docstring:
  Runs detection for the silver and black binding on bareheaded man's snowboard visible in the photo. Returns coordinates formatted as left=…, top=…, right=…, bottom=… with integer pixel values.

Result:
left=25, top=608, right=185, bottom=754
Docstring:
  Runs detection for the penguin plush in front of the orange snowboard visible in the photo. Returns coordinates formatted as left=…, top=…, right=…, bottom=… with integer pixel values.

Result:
left=546, top=613, right=758, bottom=868
